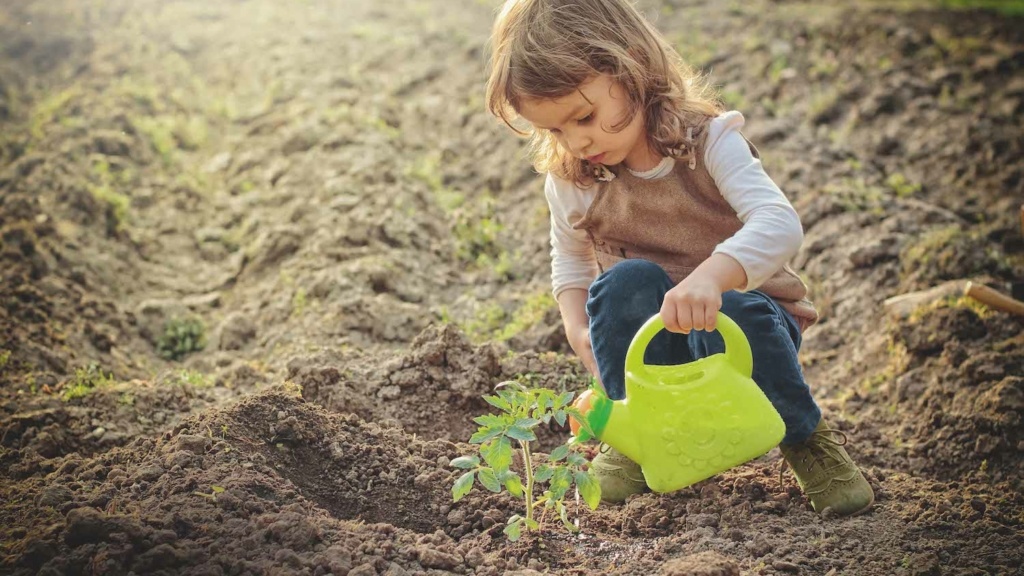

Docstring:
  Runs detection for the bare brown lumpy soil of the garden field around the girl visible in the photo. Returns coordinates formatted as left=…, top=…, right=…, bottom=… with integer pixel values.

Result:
left=0, top=0, right=1024, bottom=576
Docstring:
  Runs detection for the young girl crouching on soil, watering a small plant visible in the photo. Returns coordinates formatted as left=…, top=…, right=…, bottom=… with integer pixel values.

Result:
left=486, top=0, right=874, bottom=516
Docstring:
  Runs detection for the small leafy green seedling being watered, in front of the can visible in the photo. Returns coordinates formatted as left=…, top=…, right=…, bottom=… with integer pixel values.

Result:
left=452, top=381, right=601, bottom=541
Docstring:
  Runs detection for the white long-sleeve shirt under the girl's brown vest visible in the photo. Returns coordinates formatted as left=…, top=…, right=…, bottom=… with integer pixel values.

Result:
left=544, top=112, right=804, bottom=298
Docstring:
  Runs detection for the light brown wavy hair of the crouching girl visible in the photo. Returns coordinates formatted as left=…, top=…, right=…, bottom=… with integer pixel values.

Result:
left=485, top=0, right=723, bottom=187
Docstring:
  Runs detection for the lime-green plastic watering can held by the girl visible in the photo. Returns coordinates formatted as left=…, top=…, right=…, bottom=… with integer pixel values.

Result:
left=570, top=313, right=785, bottom=492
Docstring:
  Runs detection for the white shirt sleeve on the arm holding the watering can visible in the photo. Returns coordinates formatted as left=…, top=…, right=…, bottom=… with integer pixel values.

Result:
left=705, top=112, right=804, bottom=291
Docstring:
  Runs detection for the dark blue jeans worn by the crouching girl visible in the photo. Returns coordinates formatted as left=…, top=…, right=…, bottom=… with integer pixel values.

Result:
left=587, top=259, right=821, bottom=444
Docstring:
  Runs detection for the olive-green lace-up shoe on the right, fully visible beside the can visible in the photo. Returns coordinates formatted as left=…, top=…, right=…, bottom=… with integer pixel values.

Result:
left=779, top=418, right=874, bottom=516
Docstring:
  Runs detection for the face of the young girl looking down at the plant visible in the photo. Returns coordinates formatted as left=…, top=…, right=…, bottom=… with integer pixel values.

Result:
left=518, top=74, right=660, bottom=170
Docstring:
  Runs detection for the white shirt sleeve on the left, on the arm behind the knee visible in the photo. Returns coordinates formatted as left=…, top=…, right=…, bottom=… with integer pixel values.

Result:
left=544, top=174, right=598, bottom=299
